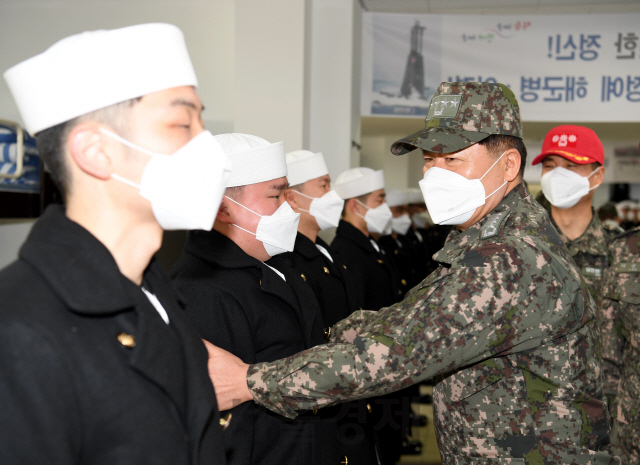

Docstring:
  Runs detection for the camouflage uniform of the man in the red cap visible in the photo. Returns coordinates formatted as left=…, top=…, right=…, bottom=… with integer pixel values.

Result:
left=549, top=208, right=620, bottom=299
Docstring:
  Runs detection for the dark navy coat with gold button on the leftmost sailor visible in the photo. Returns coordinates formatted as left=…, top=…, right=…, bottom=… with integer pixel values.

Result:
left=0, top=205, right=225, bottom=465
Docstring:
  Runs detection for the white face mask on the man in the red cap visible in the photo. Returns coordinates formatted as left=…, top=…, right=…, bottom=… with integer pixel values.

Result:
left=540, top=166, right=602, bottom=208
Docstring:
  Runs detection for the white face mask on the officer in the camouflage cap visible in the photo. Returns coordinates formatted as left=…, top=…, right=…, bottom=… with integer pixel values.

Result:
left=418, top=152, right=507, bottom=225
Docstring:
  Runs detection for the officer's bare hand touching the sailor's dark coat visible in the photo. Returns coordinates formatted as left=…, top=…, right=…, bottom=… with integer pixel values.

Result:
left=202, top=339, right=253, bottom=410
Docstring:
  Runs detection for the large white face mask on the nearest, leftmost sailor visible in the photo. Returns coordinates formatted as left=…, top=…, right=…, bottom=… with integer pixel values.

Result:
left=100, top=128, right=231, bottom=231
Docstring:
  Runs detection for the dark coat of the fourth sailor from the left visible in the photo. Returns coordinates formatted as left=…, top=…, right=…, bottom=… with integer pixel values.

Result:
left=331, top=220, right=399, bottom=310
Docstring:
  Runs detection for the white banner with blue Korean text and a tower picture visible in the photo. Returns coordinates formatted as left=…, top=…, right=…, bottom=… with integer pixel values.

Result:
left=361, top=13, right=640, bottom=122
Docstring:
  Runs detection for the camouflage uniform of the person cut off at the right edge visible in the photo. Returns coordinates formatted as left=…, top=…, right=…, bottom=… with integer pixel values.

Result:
left=602, top=228, right=640, bottom=464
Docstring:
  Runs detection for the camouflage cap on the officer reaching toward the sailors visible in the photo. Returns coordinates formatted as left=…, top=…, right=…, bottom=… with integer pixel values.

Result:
left=391, top=82, right=522, bottom=155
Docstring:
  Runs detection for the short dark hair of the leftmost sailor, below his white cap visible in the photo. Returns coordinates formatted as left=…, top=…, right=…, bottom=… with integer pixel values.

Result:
left=35, top=97, right=142, bottom=199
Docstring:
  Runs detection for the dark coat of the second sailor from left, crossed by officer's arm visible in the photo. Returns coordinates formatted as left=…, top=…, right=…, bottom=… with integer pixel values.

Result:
left=171, top=230, right=340, bottom=465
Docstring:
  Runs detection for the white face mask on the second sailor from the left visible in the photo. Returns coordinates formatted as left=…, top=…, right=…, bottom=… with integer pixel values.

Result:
left=225, top=195, right=300, bottom=257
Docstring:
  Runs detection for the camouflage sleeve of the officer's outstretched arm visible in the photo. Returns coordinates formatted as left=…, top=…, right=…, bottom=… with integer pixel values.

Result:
left=247, top=241, right=585, bottom=418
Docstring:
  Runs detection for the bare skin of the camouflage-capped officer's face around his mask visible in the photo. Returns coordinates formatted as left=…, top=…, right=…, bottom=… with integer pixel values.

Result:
left=422, top=144, right=513, bottom=231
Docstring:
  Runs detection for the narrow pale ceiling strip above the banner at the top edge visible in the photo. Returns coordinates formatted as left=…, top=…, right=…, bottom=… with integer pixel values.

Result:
left=359, top=0, right=640, bottom=14
